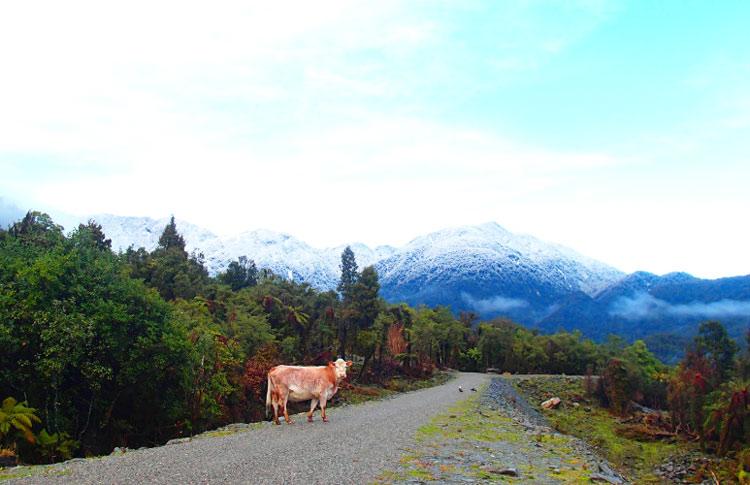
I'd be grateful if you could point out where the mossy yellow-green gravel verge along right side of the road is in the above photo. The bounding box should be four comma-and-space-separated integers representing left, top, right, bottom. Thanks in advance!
388, 377, 628, 485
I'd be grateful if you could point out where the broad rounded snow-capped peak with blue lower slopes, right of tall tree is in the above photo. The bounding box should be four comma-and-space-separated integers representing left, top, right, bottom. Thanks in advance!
377, 223, 624, 324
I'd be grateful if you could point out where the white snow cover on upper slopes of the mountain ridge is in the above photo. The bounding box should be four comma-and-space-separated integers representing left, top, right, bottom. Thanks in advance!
87, 214, 622, 294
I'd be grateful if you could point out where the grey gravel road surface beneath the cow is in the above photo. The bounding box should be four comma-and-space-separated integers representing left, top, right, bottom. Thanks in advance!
9, 373, 490, 484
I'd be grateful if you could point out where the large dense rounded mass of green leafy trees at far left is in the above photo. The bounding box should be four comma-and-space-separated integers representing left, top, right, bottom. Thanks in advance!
0, 224, 194, 451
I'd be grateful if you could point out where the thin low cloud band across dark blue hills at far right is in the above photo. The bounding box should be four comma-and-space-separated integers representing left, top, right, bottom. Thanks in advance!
609, 292, 750, 320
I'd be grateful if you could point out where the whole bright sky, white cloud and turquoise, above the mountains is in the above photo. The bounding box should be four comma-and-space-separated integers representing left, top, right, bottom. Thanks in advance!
0, 0, 750, 277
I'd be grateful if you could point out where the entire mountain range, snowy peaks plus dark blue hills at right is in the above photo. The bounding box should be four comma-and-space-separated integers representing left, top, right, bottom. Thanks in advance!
2, 206, 750, 354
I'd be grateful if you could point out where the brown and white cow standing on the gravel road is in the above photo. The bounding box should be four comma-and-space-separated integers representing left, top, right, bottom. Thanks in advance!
266, 359, 352, 424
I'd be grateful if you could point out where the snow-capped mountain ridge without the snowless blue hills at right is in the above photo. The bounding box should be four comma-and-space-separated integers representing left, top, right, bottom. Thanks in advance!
82, 215, 624, 324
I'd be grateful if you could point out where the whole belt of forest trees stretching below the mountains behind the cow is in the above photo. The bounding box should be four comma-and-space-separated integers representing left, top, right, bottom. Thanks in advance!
0, 212, 750, 463
